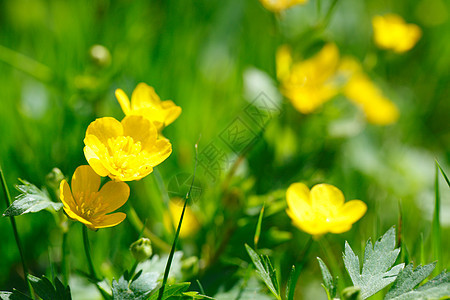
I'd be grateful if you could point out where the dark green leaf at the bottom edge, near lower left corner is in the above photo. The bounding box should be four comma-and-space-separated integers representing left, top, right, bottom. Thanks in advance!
28, 274, 72, 300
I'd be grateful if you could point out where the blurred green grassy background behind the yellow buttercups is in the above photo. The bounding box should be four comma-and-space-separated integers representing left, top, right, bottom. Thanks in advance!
0, 0, 450, 299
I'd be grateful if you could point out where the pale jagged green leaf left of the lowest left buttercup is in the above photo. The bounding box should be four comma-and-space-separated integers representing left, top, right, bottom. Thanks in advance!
3, 179, 63, 217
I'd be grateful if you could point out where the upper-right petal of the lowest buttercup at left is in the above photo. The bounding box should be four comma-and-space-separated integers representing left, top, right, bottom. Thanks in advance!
98, 181, 130, 214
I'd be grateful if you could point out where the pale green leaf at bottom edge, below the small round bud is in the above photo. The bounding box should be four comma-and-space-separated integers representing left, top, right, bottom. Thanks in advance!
112, 272, 159, 300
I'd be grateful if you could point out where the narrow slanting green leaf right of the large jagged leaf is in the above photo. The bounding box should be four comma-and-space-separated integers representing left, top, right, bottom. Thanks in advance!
385, 263, 436, 299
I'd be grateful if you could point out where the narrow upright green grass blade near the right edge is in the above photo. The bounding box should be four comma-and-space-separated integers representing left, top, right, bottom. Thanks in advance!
432, 162, 442, 273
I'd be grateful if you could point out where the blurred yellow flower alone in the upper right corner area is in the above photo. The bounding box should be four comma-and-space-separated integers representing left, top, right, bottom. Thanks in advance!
372, 14, 422, 53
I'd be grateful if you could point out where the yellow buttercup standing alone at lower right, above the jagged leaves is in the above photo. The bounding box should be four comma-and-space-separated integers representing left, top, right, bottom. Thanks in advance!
286, 183, 367, 236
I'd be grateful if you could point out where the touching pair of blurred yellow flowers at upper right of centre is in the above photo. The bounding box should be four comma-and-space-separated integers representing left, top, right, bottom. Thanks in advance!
276, 43, 399, 125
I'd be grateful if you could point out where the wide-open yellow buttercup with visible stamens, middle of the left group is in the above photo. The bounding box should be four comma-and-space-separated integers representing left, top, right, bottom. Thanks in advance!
84, 115, 172, 181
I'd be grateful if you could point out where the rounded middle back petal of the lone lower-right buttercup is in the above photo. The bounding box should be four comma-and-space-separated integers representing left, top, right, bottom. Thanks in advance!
311, 183, 345, 210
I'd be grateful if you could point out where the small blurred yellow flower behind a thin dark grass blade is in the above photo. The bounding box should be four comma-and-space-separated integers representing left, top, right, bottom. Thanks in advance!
163, 197, 200, 238
